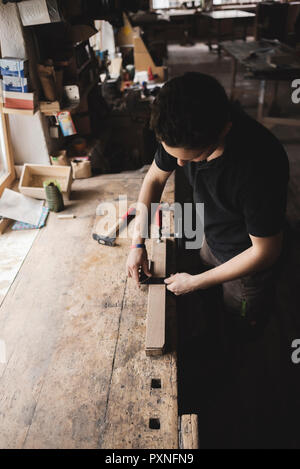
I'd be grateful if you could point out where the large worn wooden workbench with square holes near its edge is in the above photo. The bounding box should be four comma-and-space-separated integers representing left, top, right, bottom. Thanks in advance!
0, 171, 178, 449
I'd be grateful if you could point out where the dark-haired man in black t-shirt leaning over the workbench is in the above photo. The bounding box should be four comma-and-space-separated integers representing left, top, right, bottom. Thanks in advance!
127, 73, 289, 326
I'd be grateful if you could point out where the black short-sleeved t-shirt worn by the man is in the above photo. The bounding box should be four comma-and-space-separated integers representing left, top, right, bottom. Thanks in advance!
155, 105, 289, 262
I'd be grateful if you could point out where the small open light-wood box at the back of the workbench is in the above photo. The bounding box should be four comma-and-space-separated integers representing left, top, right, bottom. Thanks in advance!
19, 164, 72, 199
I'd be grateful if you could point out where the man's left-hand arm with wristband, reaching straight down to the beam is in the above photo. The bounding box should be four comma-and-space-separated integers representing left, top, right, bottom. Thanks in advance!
126, 161, 172, 284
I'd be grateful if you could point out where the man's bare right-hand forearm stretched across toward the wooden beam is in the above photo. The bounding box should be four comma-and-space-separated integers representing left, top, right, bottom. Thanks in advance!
166, 233, 282, 295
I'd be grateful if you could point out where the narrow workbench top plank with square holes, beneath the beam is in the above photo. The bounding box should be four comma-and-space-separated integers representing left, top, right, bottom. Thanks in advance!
101, 238, 179, 449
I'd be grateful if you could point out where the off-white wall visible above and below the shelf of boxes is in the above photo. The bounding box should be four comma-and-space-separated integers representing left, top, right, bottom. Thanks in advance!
0, 2, 50, 165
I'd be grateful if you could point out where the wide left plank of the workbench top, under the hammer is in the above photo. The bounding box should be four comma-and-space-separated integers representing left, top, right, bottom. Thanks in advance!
0, 177, 141, 448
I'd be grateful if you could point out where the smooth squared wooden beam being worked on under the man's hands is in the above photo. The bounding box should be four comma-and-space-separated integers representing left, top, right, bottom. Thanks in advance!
146, 239, 166, 356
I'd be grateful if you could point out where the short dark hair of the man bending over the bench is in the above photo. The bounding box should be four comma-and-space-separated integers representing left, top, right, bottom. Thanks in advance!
150, 72, 230, 149
